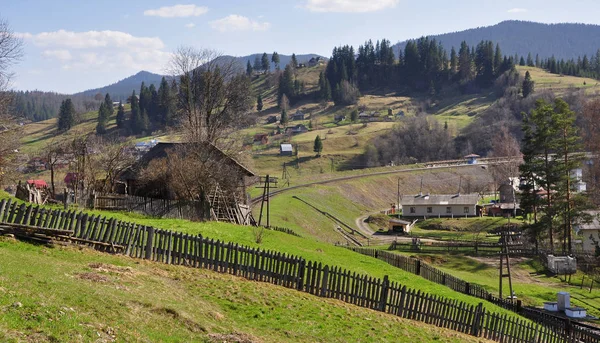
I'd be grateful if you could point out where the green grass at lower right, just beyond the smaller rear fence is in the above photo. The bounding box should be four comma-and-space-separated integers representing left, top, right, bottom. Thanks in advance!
392, 253, 600, 316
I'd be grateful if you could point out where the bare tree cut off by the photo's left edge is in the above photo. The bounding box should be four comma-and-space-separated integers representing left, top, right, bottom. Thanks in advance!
0, 19, 23, 184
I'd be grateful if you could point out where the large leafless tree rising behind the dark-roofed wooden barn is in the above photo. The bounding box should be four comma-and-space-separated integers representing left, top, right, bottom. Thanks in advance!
168, 47, 252, 143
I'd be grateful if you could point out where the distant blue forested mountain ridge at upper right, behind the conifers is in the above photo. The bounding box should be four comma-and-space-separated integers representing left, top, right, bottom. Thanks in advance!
394, 20, 600, 59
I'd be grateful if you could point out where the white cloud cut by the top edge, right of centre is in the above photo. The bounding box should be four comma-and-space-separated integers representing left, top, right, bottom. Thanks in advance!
304, 0, 399, 13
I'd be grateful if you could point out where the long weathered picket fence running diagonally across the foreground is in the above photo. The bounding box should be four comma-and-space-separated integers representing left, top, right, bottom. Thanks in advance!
0, 200, 600, 343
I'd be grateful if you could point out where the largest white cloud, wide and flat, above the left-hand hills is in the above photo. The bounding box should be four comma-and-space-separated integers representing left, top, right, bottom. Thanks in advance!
18, 30, 171, 72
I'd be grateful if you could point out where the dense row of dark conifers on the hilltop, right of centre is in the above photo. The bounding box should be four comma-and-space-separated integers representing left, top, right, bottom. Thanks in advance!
318, 37, 518, 105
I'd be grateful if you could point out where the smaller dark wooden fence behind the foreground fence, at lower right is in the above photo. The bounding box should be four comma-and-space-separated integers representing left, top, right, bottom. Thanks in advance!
349, 247, 600, 342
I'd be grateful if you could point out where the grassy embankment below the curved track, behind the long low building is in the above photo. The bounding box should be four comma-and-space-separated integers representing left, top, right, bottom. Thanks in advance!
262, 166, 490, 243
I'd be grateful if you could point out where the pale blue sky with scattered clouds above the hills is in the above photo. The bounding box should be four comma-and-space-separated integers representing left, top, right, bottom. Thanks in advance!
0, 0, 600, 94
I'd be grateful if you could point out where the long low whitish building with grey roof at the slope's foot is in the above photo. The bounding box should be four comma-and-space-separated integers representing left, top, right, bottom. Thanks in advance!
400, 194, 480, 218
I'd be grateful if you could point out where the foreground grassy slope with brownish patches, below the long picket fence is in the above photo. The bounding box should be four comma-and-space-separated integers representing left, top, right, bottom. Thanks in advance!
0, 240, 488, 342
